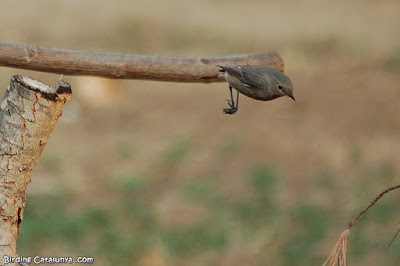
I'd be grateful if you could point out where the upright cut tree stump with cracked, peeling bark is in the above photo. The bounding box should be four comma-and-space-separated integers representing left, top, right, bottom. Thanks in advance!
0, 76, 72, 265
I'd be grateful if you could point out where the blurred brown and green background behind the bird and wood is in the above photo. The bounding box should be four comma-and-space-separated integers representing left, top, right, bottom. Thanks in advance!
0, 0, 400, 265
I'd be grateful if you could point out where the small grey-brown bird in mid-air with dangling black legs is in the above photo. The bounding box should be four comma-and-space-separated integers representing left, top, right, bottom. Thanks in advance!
219, 65, 296, 114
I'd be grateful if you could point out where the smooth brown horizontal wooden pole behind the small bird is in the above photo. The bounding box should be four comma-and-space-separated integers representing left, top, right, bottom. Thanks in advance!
0, 42, 284, 83
